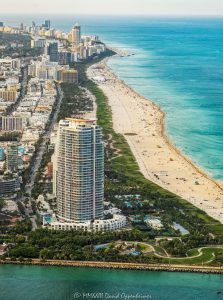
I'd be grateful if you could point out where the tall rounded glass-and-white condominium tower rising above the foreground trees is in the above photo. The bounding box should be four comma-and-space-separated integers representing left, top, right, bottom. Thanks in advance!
54, 119, 104, 222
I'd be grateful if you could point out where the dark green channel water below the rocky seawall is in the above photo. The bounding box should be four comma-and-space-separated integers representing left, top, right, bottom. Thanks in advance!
0, 265, 223, 300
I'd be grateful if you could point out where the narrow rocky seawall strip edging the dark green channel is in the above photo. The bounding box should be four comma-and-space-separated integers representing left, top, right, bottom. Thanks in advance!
0, 258, 223, 275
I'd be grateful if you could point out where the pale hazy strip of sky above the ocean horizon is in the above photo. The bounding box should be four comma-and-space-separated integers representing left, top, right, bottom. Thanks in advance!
0, 0, 223, 15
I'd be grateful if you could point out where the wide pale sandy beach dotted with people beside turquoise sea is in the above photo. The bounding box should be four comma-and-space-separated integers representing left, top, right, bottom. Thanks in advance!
87, 59, 223, 223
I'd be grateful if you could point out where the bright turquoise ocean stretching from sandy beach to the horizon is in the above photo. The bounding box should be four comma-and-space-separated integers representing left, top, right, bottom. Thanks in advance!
0, 15, 223, 181
